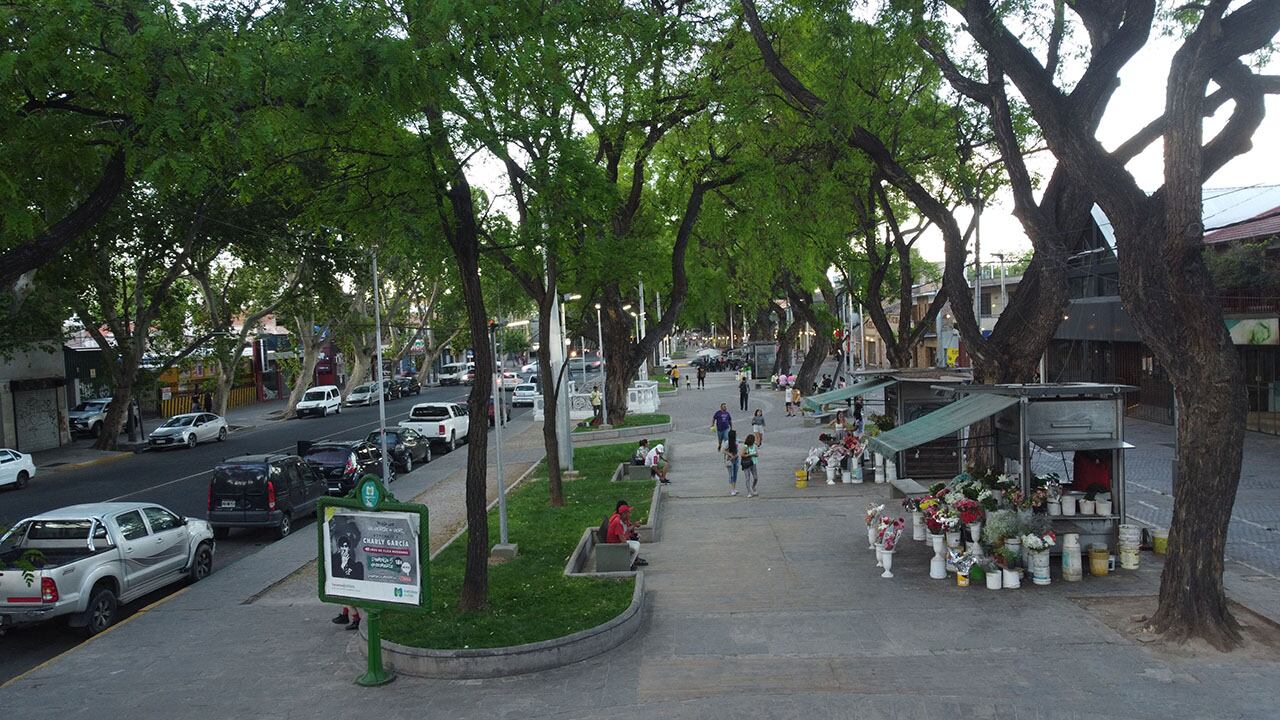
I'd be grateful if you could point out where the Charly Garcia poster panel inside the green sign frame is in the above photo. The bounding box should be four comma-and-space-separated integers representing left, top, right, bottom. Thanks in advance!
323, 507, 422, 606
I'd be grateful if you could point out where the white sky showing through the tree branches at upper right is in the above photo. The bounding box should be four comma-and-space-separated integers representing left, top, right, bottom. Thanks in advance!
919, 35, 1280, 263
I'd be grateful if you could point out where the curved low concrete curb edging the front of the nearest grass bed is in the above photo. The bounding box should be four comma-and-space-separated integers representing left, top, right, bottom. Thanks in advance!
358, 573, 645, 680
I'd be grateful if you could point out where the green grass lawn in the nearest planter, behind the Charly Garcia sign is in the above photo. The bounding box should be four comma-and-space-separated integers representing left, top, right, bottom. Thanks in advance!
383, 442, 654, 650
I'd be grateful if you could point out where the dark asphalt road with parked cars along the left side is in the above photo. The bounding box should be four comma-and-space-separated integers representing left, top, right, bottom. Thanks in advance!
0, 387, 527, 683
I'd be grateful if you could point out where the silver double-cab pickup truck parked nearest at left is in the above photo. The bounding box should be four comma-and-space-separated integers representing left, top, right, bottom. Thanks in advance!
0, 502, 215, 635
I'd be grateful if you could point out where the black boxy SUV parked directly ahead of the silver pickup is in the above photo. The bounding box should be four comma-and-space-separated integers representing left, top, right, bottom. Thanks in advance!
207, 454, 326, 538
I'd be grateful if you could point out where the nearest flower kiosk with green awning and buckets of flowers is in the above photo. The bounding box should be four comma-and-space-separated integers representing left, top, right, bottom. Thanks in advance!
868, 383, 1138, 587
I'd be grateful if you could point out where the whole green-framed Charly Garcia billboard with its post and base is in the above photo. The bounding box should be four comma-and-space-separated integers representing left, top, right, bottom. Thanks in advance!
316, 475, 431, 687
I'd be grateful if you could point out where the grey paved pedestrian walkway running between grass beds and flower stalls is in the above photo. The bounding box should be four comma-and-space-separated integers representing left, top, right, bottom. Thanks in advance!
0, 366, 1280, 720
